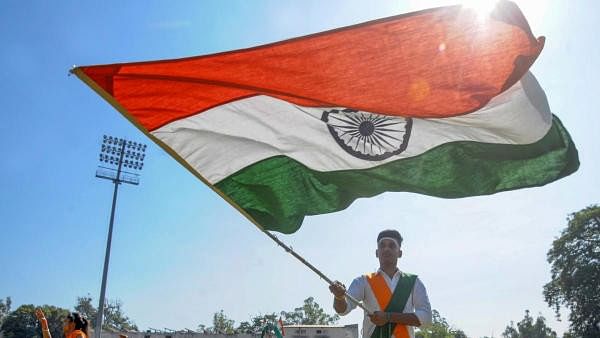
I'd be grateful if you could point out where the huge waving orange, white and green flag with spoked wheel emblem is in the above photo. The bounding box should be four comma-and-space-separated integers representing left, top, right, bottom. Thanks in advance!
73, 1, 579, 233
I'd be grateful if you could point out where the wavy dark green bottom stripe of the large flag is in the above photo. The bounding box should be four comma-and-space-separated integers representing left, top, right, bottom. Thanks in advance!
216, 117, 579, 233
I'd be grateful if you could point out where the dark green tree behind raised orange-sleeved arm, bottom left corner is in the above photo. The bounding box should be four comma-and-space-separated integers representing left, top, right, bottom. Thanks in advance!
2, 304, 69, 338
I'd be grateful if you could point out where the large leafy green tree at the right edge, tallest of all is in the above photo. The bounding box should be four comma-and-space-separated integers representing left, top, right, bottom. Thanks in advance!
544, 205, 600, 338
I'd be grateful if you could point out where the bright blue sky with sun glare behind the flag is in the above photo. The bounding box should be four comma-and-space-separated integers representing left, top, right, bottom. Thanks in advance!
0, 0, 600, 337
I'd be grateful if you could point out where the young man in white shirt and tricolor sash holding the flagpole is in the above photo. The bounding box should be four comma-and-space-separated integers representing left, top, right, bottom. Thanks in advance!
329, 230, 431, 338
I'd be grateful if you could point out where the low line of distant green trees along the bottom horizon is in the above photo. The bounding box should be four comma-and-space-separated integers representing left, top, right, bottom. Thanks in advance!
0, 290, 556, 338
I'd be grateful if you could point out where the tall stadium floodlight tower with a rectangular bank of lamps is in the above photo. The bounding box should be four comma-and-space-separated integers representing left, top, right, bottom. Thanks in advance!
94, 135, 146, 338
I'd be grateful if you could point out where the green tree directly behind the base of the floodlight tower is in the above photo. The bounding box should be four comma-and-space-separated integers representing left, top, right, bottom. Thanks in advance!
75, 295, 138, 331
